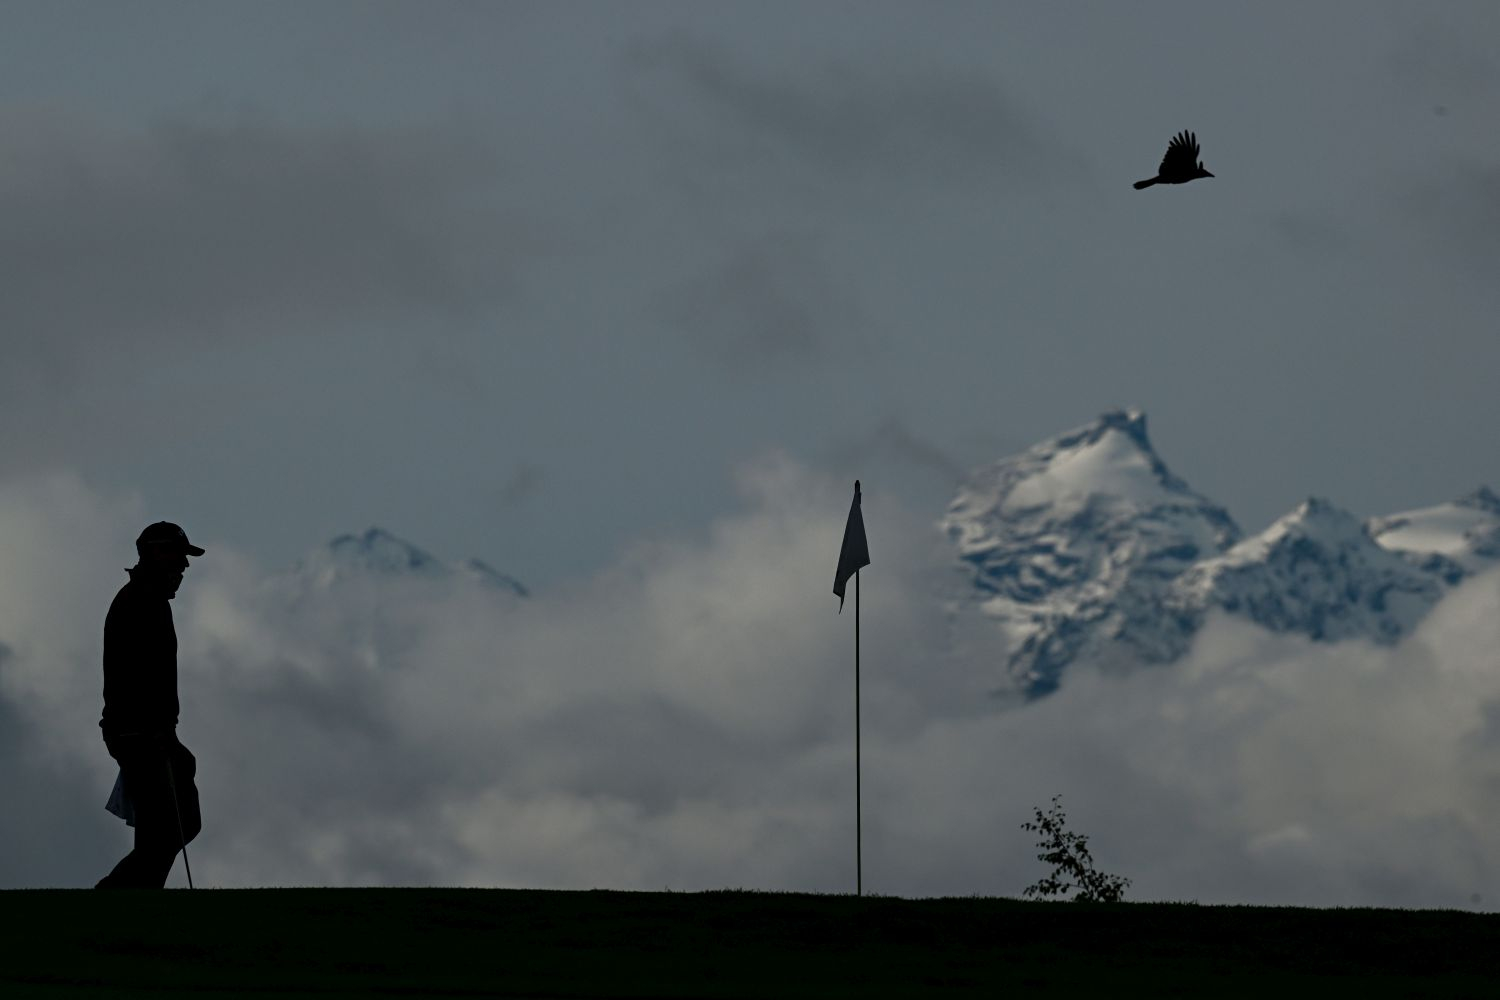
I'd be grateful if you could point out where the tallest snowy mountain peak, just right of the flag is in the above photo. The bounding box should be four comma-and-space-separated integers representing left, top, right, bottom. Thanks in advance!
941, 409, 1241, 694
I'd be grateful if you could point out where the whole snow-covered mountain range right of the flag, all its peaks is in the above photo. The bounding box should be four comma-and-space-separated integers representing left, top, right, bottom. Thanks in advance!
939, 409, 1500, 696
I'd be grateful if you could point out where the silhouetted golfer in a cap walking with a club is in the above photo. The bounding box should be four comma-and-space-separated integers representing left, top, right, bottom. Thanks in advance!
96, 520, 203, 889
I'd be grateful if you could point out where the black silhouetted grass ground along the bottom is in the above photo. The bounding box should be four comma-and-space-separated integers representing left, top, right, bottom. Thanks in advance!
0, 889, 1500, 1000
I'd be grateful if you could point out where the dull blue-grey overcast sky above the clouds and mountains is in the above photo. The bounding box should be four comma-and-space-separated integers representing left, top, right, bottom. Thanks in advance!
0, 3, 1500, 586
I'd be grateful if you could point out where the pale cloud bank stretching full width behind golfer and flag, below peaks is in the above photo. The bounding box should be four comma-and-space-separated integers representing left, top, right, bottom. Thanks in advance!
0, 459, 1500, 907
